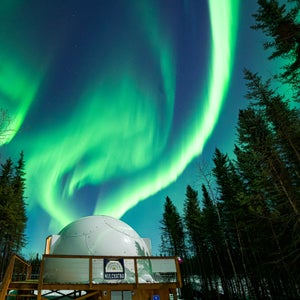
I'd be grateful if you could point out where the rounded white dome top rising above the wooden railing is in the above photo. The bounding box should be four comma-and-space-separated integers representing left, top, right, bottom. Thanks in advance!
50, 215, 150, 256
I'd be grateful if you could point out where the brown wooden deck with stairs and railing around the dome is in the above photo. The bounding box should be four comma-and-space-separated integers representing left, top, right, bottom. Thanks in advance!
0, 255, 181, 300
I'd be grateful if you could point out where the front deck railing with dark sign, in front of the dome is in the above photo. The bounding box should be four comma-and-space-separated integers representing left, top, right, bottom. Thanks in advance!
40, 255, 181, 286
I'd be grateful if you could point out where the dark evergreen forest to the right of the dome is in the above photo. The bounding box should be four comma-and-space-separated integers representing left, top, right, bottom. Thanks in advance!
161, 0, 300, 299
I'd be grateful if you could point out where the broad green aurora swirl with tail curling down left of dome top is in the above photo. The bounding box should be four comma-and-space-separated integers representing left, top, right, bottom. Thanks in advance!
27, 70, 166, 228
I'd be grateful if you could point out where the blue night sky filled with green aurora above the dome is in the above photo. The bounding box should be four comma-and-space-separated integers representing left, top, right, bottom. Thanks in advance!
0, 0, 272, 254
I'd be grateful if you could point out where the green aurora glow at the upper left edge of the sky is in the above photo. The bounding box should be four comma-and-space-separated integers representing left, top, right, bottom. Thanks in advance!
0, 0, 52, 146
